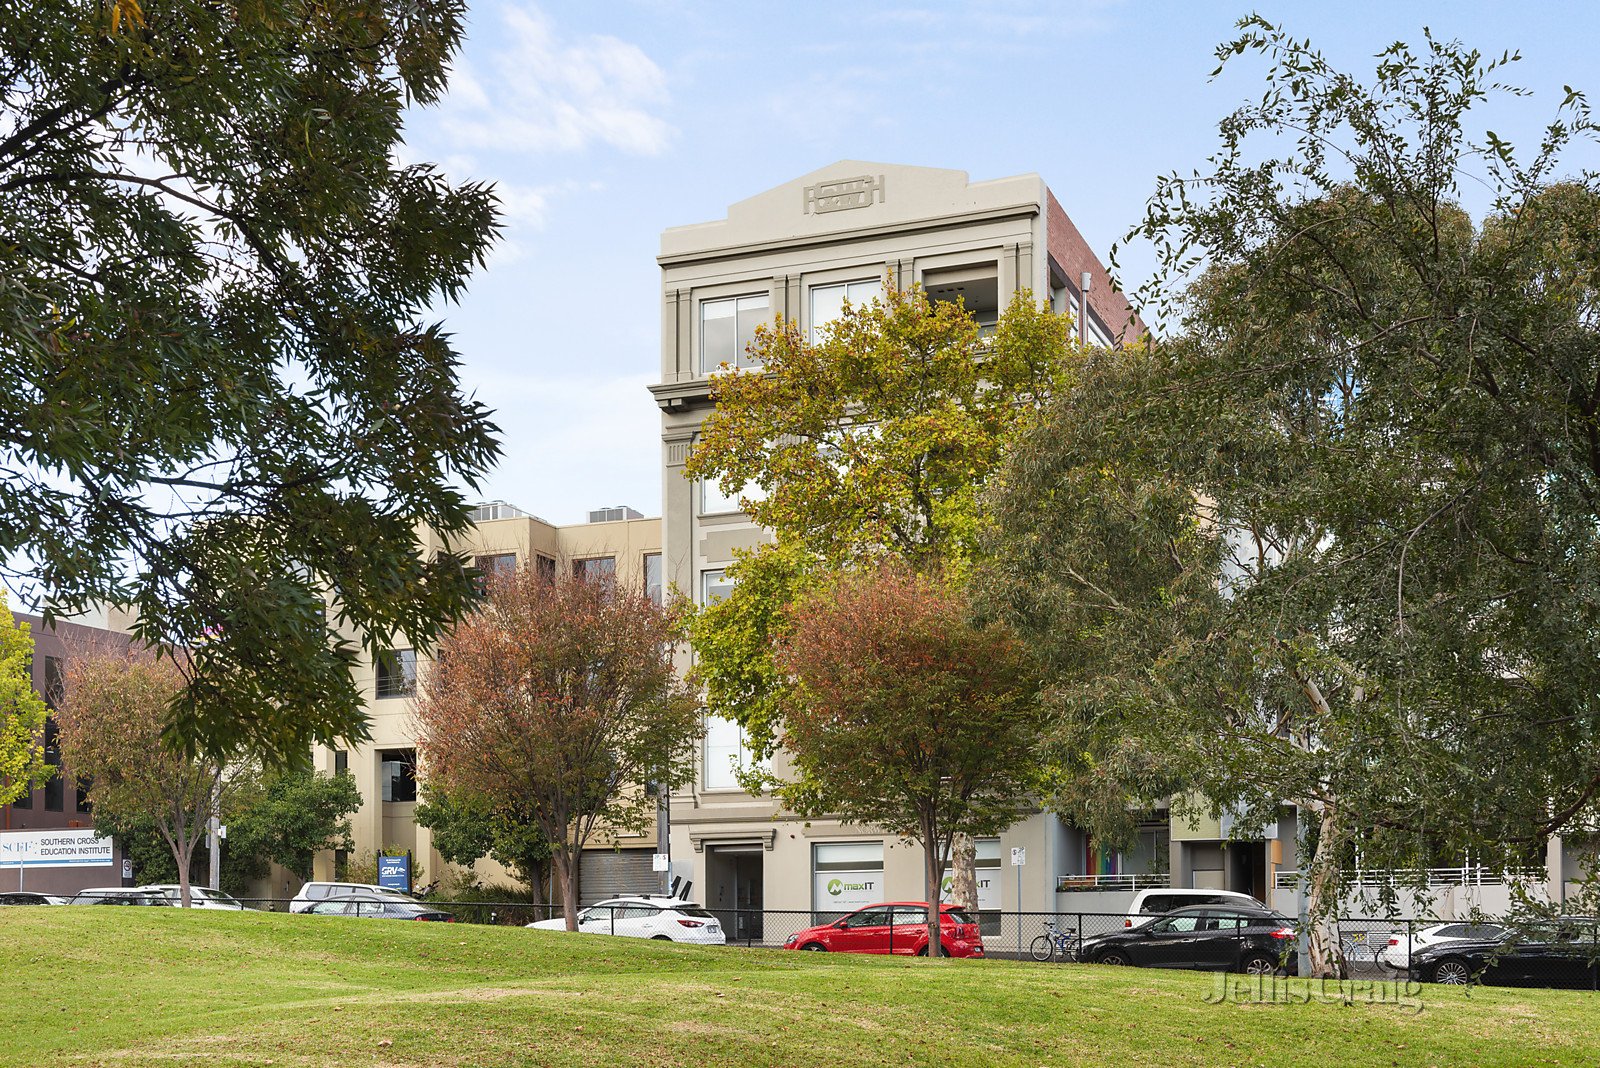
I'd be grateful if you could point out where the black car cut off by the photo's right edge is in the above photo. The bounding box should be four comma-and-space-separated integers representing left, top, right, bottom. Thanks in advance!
1410, 916, 1600, 990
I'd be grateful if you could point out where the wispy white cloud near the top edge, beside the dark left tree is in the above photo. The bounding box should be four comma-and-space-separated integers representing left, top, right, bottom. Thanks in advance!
437, 5, 674, 155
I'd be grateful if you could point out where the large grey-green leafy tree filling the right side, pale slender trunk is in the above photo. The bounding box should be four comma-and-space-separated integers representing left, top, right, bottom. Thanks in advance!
992, 18, 1600, 974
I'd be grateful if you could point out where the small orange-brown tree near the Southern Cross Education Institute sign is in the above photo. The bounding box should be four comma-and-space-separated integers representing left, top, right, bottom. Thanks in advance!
56, 654, 229, 908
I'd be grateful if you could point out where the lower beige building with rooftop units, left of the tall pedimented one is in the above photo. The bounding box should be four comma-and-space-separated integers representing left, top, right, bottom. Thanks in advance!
305, 502, 662, 900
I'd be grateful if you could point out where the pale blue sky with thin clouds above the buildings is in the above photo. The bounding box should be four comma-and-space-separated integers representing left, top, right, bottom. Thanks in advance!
400, 0, 1600, 523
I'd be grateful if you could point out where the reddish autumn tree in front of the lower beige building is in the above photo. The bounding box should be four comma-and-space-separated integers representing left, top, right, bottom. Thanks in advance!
418, 568, 701, 931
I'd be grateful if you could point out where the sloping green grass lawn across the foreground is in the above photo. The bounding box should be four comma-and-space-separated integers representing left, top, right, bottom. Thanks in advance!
0, 908, 1600, 1068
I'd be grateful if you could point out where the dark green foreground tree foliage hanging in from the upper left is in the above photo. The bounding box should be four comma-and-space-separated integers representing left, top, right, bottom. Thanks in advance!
0, 0, 498, 761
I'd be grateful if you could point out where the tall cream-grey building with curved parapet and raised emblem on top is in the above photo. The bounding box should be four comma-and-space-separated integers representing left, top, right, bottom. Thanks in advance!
650, 160, 1170, 937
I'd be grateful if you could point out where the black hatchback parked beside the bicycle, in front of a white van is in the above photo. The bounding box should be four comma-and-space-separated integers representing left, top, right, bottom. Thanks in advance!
1078, 905, 1296, 975
